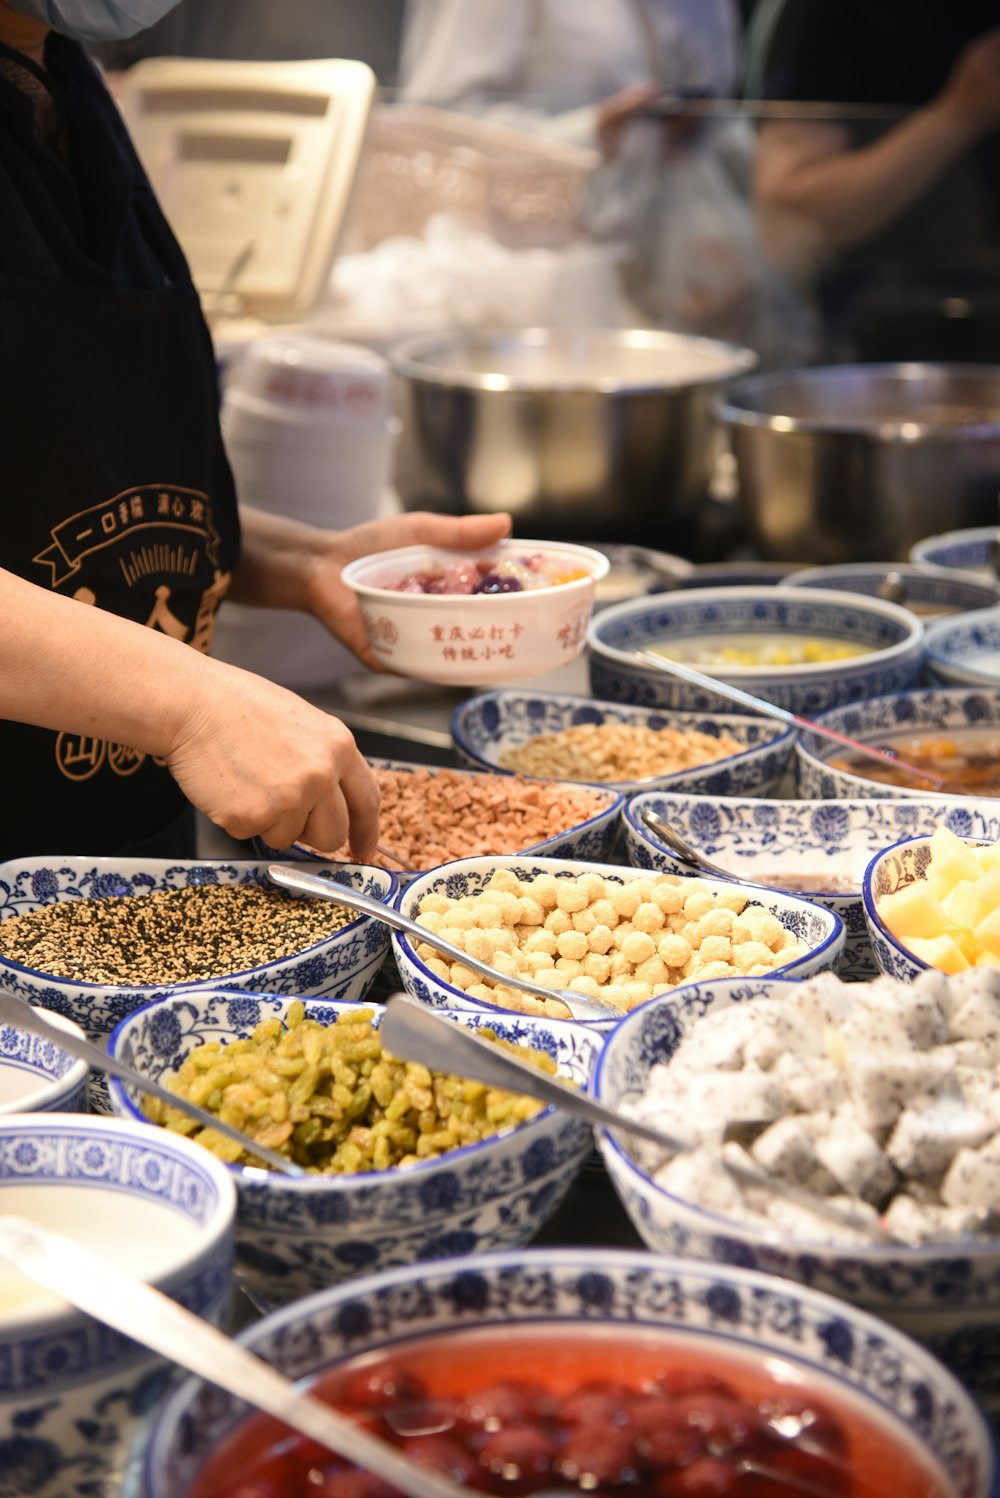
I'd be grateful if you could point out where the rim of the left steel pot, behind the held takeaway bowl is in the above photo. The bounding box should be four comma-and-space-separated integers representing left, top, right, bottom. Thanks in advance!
388, 327, 757, 395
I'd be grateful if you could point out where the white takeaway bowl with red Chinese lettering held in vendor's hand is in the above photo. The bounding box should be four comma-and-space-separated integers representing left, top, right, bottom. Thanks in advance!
341, 541, 609, 686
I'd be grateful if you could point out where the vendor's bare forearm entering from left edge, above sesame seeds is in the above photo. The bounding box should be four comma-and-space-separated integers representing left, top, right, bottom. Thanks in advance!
0, 571, 213, 755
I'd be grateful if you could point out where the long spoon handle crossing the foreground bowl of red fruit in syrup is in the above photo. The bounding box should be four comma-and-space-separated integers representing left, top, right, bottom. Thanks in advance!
0, 1216, 469, 1498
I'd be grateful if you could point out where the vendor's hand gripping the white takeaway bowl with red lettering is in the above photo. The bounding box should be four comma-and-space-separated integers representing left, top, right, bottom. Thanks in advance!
308, 509, 510, 668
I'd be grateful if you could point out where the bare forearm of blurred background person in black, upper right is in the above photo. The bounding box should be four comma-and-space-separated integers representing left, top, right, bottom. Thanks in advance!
757, 103, 970, 250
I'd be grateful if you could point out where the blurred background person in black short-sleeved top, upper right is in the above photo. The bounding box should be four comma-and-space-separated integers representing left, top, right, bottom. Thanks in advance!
749, 0, 1000, 360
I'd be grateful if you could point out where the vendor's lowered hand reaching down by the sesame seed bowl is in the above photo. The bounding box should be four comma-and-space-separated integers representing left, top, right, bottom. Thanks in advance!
163, 658, 379, 863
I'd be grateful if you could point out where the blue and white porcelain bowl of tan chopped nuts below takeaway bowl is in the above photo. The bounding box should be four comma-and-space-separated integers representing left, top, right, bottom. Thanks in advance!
452, 691, 793, 802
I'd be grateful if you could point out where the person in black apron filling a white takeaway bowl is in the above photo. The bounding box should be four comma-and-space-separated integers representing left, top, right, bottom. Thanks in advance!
0, 0, 504, 860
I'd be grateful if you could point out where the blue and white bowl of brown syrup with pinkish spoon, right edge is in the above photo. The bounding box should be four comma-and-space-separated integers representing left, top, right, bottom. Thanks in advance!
795, 686, 1000, 802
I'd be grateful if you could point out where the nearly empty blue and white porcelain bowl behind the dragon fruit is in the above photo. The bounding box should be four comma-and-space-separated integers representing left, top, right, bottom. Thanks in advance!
624, 791, 1000, 981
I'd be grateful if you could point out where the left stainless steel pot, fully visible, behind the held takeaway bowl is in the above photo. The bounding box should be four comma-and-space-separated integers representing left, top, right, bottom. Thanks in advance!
391, 328, 756, 545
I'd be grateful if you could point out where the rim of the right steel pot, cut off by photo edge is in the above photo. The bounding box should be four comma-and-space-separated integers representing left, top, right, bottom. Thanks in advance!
713, 360, 1000, 446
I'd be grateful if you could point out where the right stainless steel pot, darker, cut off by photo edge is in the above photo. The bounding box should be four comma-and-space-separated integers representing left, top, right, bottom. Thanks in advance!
716, 364, 1000, 563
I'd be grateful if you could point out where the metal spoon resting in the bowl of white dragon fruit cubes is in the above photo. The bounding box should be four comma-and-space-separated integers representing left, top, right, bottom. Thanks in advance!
379, 993, 900, 1243
